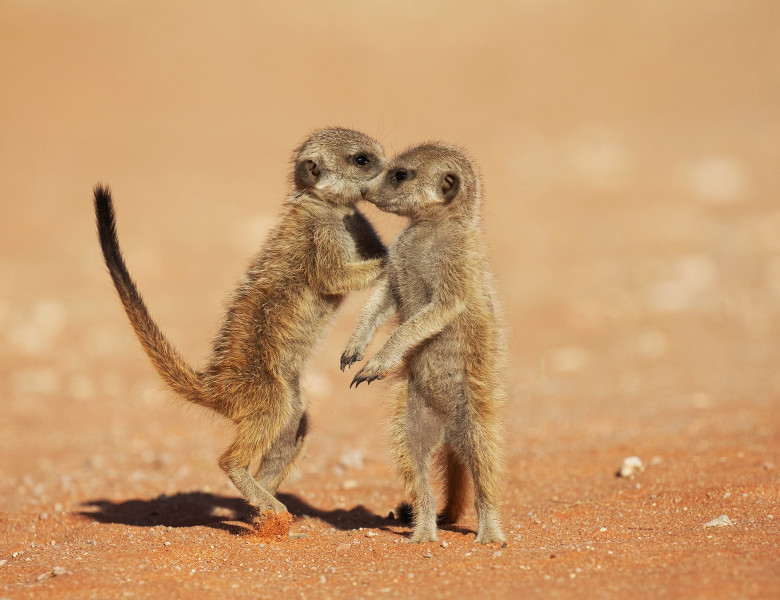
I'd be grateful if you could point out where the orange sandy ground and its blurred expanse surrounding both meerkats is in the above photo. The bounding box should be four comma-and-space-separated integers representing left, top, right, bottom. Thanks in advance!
0, 0, 780, 599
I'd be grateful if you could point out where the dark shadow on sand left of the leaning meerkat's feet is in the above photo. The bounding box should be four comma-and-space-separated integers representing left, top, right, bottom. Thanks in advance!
79, 492, 252, 535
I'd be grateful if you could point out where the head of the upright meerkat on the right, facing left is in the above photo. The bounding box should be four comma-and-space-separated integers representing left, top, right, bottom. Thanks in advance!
366, 142, 481, 219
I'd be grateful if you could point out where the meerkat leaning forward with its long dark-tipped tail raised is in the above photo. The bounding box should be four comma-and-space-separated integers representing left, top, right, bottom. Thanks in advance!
94, 128, 386, 516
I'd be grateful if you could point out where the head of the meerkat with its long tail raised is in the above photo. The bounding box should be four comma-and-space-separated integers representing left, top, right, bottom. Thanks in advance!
293, 127, 387, 204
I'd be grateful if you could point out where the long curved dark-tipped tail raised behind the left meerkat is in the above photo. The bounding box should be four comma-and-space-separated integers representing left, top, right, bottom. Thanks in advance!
94, 184, 210, 406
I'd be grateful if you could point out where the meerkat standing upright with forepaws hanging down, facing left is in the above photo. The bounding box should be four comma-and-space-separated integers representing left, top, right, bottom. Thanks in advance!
341, 143, 505, 544
